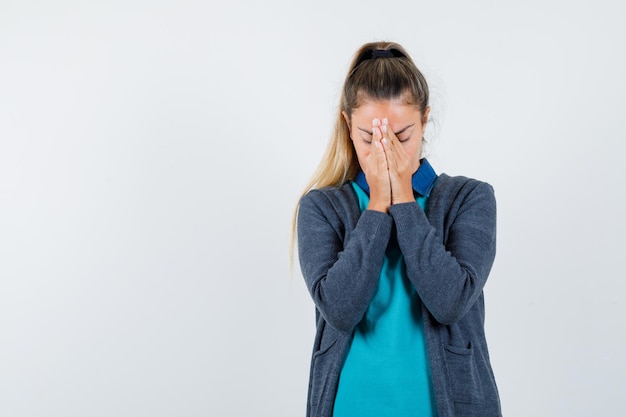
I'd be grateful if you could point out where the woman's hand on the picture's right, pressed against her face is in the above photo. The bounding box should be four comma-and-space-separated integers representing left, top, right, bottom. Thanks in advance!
381, 118, 415, 204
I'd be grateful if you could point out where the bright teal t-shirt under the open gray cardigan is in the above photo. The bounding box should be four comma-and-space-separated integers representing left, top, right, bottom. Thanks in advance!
333, 182, 437, 417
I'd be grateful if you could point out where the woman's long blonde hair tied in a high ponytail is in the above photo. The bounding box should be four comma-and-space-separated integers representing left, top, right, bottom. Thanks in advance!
289, 42, 429, 266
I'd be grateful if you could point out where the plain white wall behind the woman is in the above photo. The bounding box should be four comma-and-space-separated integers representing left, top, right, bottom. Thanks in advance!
0, 0, 626, 417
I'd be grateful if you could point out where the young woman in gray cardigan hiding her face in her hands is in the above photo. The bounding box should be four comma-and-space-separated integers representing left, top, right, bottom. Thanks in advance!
290, 42, 501, 417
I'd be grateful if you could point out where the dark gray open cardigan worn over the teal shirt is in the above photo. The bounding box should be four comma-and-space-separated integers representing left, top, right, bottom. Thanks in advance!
298, 174, 501, 417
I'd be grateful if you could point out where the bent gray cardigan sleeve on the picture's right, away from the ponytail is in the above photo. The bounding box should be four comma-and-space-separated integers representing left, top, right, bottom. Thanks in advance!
390, 181, 496, 325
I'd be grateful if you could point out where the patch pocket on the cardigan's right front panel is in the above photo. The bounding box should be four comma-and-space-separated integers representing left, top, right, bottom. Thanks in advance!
445, 343, 484, 404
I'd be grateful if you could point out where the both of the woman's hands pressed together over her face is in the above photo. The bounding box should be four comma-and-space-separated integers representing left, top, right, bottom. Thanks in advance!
362, 118, 415, 213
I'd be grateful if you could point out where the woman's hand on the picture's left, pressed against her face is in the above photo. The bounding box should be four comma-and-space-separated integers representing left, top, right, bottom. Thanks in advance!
363, 119, 391, 213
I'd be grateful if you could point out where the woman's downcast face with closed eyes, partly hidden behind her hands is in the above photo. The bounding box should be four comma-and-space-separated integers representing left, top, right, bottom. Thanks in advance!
343, 98, 430, 173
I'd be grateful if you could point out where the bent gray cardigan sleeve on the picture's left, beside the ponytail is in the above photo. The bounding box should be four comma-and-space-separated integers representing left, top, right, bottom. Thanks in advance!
297, 190, 392, 332
